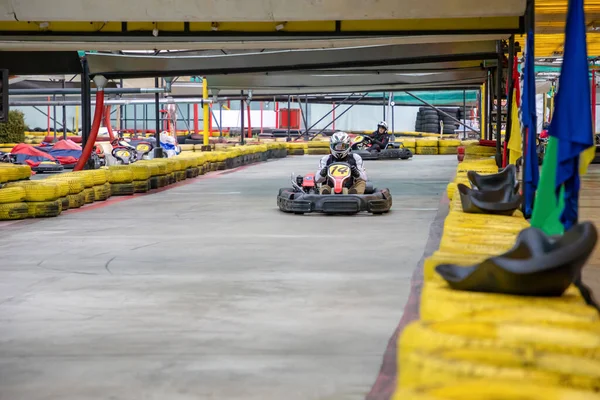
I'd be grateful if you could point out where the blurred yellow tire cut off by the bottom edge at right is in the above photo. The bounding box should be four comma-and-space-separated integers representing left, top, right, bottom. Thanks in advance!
392, 379, 600, 400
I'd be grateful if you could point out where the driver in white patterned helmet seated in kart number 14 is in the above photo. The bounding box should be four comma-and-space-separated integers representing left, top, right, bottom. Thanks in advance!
315, 132, 367, 194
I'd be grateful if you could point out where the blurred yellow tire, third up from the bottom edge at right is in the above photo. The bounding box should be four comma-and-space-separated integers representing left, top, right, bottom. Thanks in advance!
399, 318, 600, 360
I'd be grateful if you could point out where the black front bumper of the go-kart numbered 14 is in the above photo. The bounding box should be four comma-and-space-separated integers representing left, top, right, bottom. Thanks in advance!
277, 189, 392, 214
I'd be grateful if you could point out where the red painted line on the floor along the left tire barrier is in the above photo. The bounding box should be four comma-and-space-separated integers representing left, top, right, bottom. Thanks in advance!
0, 163, 259, 228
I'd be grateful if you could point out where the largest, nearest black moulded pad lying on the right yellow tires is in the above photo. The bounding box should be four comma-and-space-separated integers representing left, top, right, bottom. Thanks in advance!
435, 222, 598, 297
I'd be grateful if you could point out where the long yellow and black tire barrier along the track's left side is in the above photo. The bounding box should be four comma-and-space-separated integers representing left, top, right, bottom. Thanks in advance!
0, 143, 287, 221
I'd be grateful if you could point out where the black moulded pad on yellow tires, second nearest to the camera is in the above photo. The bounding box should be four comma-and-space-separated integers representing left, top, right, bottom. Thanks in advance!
458, 183, 523, 215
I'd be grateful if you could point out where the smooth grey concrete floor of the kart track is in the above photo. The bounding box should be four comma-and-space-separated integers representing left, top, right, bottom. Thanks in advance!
0, 156, 456, 400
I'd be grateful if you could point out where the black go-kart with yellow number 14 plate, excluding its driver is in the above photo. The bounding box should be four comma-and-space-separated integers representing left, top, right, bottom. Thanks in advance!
277, 162, 392, 214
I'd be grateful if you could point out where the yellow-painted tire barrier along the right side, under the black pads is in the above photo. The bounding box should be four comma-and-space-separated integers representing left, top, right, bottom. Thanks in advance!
393, 159, 600, 400
